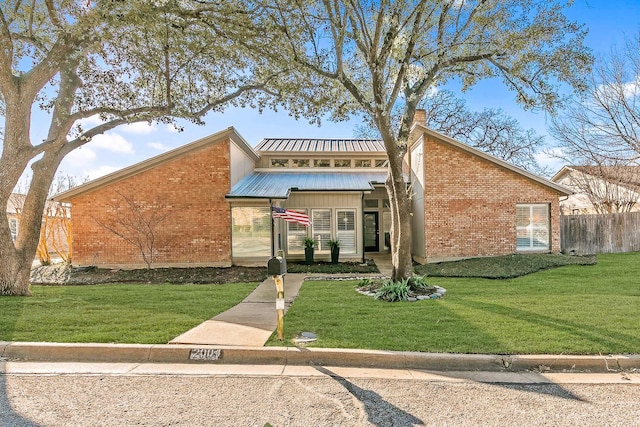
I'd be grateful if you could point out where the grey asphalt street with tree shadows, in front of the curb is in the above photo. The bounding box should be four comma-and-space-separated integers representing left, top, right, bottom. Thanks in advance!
0, 362, 640, 427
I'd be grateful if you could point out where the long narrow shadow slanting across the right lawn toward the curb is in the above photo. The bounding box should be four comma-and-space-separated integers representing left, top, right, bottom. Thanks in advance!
456, 299, 638, 353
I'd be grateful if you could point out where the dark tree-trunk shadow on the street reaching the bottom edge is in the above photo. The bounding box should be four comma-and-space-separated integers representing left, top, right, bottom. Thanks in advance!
314, 366, 424, 426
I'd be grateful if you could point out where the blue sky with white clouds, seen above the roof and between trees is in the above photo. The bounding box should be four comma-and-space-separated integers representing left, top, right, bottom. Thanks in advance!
53, 0, 640, 179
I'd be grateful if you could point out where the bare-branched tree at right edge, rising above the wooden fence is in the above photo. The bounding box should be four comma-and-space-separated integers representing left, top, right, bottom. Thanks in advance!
549, 36, 640, 217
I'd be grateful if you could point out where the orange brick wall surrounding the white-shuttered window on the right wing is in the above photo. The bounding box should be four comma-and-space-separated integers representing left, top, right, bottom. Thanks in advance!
424, 135, 560, 259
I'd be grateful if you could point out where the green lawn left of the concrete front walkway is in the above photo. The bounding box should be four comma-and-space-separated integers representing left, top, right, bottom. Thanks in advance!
0, 283, 256, 344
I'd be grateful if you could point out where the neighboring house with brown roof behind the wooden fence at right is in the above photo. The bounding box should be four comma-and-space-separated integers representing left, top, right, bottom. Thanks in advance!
551, 166, 640, 215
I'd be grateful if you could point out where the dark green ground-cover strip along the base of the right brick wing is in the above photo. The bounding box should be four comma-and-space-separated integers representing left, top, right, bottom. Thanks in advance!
415, 254, 596, 279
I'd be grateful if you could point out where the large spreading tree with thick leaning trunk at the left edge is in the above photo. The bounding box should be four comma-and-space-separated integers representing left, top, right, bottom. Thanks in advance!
0, 0, 322, 295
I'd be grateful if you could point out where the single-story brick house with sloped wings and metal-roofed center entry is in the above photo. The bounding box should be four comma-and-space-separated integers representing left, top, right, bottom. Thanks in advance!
55, 115, 571, 267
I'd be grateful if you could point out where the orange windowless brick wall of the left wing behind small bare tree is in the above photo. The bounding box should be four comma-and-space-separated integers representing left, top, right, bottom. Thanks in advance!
71, 140, 231, 268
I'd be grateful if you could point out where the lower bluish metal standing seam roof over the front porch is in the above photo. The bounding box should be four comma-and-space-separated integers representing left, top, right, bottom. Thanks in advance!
227, 171, 387, 199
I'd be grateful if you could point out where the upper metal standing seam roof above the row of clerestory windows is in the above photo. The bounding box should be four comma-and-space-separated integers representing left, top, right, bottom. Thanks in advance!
255, 138, 386, 153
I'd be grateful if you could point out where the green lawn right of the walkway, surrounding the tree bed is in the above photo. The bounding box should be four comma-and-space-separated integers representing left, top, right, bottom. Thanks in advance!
268, 253, 640, 354
